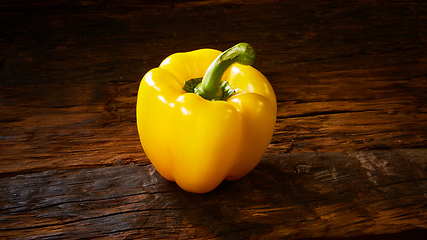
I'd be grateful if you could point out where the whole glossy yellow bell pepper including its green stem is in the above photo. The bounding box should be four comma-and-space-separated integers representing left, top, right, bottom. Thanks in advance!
136, 43, 277, 193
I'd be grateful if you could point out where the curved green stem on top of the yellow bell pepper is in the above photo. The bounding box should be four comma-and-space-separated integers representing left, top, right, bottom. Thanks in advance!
194, 43, 255, 101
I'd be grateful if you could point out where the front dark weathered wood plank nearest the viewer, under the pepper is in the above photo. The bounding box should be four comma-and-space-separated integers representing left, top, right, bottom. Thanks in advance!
0, 149, 427, 239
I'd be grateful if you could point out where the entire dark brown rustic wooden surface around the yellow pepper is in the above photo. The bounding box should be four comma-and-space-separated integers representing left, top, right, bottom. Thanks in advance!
0, 0, 427, 239
